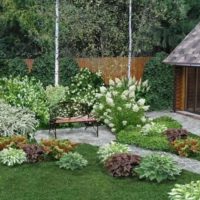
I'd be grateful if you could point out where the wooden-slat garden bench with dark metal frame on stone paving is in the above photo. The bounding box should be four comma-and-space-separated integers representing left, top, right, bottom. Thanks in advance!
49, 102, 99, 138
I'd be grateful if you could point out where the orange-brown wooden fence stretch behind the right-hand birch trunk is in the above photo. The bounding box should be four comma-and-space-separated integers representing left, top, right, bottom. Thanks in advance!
76, 57, 150, 84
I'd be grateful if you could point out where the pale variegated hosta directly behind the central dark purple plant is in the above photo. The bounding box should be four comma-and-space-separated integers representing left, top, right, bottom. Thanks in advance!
97, 142, 129, 163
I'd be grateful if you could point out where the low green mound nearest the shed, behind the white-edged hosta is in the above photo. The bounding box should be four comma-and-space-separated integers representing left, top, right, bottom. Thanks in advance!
153, 116, 182, 128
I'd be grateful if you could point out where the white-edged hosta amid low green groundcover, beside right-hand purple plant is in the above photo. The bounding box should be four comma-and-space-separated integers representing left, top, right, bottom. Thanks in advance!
141, 122, 168, 135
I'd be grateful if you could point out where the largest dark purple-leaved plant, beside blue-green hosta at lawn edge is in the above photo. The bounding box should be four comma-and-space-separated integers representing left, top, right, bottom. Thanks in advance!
105, 153, 141, 177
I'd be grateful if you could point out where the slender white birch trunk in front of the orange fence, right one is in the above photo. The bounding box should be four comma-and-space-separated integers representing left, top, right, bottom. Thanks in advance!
128, 0, 132, 79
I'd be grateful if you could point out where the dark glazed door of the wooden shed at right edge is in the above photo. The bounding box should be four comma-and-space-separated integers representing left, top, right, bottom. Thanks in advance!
186, 67, 200, 113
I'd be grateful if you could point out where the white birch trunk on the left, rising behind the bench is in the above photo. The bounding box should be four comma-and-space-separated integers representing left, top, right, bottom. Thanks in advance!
55, 0, 59, 86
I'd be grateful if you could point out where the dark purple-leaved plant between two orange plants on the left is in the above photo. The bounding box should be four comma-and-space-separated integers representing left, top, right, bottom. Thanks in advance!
22, 144, 44, 163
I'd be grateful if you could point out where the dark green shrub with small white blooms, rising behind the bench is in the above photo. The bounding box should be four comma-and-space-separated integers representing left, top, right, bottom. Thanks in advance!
66, 68, 103, 106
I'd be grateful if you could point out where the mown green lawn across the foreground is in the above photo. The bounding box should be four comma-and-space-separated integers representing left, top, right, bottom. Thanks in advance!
0, 145, 200, 200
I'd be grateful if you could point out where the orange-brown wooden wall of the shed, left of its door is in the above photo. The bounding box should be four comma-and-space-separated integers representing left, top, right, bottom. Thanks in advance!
175, 67, 186, 110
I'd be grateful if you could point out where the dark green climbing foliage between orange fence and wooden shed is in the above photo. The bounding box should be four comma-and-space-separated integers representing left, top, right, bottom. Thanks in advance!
143, 52, 174, 110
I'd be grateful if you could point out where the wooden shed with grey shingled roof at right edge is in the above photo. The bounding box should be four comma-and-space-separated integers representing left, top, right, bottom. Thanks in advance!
164, 23, 200, 114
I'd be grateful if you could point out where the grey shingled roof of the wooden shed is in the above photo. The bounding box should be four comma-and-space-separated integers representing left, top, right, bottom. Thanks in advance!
163, 23, 200, 66
